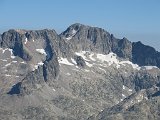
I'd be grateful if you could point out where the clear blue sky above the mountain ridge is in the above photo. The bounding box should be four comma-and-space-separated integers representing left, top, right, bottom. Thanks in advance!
0, 0, 160, 51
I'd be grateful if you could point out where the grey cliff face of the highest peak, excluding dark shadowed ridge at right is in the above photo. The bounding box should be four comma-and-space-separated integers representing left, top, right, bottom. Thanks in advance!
60, 23, 132, 59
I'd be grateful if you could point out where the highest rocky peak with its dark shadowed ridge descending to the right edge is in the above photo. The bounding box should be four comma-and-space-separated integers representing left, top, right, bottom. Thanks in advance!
60, 23, 160, 67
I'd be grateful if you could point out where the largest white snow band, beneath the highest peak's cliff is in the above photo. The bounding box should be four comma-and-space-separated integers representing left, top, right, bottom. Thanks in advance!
74, 51, 157, 70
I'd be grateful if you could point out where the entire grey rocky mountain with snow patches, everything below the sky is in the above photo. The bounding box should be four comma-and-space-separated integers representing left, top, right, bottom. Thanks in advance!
0, 23, 160, 120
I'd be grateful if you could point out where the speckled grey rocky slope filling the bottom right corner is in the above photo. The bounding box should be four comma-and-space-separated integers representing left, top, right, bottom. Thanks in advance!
89, 97, 160, 120
